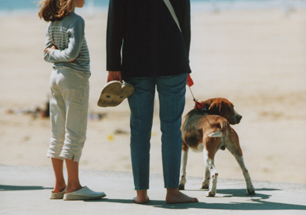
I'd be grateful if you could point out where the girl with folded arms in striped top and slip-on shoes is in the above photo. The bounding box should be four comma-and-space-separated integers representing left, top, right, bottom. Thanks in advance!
38, 0, 105, 200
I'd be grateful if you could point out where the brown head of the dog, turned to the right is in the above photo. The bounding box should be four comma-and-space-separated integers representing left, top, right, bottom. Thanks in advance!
201, 98, 242, 125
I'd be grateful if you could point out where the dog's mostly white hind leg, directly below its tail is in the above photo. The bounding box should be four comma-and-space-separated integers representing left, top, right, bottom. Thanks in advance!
203, 148, 218, 197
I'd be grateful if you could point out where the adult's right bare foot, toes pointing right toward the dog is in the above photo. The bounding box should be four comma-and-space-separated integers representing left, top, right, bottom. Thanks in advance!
166, 188, 199, 204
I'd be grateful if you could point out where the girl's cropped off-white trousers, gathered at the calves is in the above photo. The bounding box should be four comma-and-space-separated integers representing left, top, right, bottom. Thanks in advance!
47, 67, 90, 162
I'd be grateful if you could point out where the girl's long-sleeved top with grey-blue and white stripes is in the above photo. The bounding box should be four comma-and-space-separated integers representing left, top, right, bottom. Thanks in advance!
44, 12, 90, 72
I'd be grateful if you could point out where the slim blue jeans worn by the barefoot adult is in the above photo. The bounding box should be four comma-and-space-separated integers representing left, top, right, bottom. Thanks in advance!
128, 74, 187, 190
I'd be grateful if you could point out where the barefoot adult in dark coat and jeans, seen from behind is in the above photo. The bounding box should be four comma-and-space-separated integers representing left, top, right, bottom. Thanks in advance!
107, 0, 198, 203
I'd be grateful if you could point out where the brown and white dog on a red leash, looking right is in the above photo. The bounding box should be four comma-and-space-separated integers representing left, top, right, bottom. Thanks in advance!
180, 98, 255, 197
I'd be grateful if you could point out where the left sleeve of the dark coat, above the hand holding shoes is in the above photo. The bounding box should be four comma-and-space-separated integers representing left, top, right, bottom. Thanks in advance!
106, 0, 126, 71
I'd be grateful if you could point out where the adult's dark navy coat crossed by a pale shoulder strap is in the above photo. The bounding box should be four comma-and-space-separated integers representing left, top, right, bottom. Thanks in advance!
107, 0, 191, 80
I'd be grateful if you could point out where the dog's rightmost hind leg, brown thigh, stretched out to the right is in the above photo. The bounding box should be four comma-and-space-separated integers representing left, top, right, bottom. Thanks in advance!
226, 129, 255, 195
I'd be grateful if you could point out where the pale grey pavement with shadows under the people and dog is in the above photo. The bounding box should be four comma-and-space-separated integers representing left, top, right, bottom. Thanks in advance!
0, 165, 306, 215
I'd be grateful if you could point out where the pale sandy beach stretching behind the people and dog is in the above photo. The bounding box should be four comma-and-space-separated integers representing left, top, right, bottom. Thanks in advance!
0, 9, 306, 184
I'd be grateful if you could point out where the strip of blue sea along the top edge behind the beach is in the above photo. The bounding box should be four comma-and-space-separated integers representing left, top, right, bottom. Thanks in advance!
0, 0, 306, 15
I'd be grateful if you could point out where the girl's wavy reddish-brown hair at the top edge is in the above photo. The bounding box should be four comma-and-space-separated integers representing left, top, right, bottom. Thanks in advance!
38, 0, 74, 22
